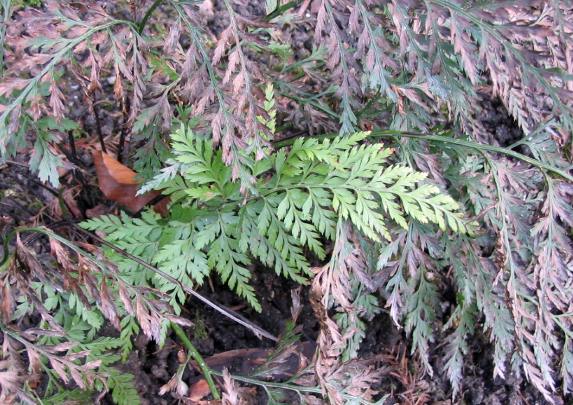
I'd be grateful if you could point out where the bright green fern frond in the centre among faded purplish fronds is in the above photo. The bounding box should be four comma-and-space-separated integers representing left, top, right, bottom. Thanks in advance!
83, 125, 468, 311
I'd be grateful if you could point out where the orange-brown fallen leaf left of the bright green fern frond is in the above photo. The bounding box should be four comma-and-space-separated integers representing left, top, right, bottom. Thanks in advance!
93, 150, 169, 215
